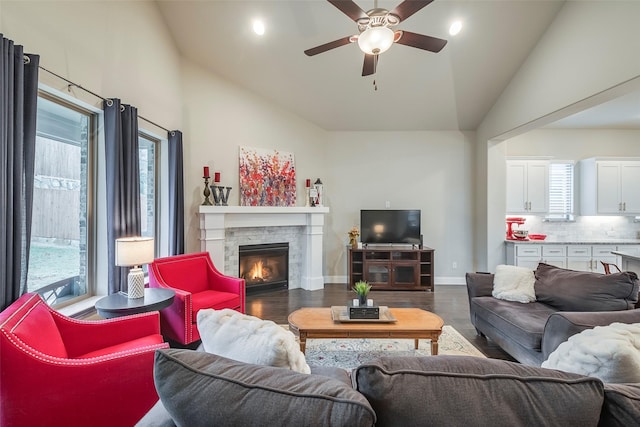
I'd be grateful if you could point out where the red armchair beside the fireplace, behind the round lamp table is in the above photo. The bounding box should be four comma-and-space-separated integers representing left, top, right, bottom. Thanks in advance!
149, 252, 245, 345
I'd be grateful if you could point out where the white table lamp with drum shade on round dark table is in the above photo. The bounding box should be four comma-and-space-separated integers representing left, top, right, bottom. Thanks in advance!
116, 236, 154, 298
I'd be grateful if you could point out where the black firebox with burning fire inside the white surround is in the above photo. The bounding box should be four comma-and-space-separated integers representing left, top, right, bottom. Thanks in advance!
238, 242, 289, 294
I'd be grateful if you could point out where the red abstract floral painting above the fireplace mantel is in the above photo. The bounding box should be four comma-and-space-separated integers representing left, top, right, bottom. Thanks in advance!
239, 147, 296, 206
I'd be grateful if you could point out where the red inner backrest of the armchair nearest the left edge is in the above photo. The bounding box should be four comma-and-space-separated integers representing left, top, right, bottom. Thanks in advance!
11, 302, 69, 359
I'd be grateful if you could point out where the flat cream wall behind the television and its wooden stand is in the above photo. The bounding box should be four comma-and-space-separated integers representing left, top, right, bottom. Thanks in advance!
322, 132, 475, 283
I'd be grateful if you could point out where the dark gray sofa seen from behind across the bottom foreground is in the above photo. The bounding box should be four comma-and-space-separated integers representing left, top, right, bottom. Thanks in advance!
138, 349, 640, 427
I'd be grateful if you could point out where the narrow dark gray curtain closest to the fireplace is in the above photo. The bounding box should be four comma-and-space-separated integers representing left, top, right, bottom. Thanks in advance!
169, 130, 184, 255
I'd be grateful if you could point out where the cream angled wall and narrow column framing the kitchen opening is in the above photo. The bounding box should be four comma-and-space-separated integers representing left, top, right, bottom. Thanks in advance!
476, 1, 640, 270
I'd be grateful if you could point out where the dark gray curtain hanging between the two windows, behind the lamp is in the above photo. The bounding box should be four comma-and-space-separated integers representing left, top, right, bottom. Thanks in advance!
103, 99, 142, 294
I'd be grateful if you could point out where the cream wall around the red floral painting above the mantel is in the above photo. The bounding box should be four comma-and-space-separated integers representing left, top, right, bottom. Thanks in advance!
183, 61, 327, 252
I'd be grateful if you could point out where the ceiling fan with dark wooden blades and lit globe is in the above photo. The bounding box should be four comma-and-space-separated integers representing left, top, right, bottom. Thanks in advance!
304, 0, 447, 76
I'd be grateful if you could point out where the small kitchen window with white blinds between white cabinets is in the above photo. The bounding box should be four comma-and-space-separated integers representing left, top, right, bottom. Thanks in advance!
547, 162, 574, 221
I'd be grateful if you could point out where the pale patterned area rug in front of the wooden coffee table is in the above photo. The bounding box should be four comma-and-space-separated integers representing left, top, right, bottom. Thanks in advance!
283, 325, 485, 370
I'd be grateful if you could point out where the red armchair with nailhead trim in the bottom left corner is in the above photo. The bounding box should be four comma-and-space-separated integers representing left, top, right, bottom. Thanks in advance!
0, 293, 169, 427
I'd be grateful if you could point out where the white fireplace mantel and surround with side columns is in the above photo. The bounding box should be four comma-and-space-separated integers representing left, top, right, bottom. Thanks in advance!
198, 206, 329, 290
